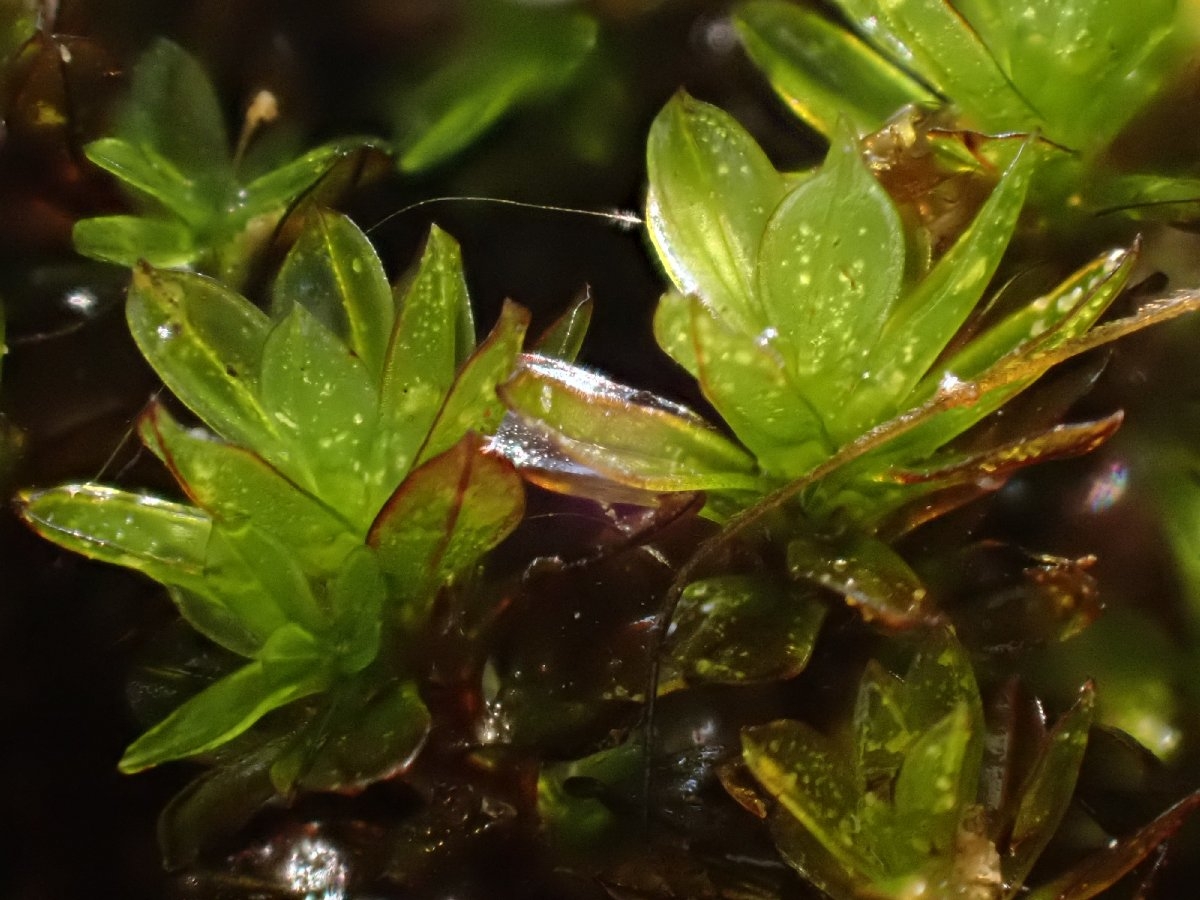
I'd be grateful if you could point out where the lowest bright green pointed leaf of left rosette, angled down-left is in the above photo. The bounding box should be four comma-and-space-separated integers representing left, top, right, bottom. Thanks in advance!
120, 626, 330, 773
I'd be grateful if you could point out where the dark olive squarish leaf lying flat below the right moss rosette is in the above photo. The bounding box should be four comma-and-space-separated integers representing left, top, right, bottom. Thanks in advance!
670, 575, 826, 684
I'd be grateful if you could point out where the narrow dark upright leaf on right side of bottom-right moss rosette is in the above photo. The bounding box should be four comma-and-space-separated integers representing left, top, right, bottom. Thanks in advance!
1003, 684, 1096, 884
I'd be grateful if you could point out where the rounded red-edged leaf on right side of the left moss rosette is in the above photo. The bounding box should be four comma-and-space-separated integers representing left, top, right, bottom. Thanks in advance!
368, 434, 524, 625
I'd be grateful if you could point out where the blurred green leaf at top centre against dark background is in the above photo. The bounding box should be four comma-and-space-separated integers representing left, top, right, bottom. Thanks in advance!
396, 10, 598, 173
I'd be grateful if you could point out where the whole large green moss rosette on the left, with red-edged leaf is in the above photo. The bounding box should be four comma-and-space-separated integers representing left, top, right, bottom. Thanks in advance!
22, 212, 527, 791
